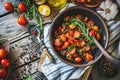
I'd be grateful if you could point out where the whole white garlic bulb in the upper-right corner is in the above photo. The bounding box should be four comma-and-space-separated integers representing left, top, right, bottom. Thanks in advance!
97, 0, 118, 20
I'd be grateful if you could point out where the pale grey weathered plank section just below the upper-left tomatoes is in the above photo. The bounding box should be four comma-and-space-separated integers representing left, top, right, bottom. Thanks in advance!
0, 14, 26, 38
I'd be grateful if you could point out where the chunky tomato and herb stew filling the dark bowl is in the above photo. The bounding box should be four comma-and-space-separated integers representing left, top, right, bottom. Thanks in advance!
53, 14, 101, 64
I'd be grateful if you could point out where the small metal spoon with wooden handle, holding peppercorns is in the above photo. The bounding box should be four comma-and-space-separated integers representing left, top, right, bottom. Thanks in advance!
28, 25, 55, 63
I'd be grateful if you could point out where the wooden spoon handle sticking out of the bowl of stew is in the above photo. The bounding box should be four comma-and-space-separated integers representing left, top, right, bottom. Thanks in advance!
93, 37, 120, 68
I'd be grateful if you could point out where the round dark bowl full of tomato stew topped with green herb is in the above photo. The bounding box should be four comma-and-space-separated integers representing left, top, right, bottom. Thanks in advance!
50, 7, 109, 67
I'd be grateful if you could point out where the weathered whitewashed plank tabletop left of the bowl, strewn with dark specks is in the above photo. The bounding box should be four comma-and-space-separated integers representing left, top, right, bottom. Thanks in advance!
0, 0, 49, 80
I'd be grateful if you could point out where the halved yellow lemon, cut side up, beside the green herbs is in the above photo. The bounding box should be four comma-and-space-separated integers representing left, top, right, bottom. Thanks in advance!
38, 5, 51, 16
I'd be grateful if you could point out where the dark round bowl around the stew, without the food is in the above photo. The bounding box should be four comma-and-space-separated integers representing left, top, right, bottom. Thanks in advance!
50, 7, 109, 67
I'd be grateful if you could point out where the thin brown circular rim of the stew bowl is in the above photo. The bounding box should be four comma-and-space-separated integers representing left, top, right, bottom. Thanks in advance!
49, 6, 109, 67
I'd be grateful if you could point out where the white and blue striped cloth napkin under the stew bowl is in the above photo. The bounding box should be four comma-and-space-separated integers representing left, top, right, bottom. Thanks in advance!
41, 3, 120, 80
